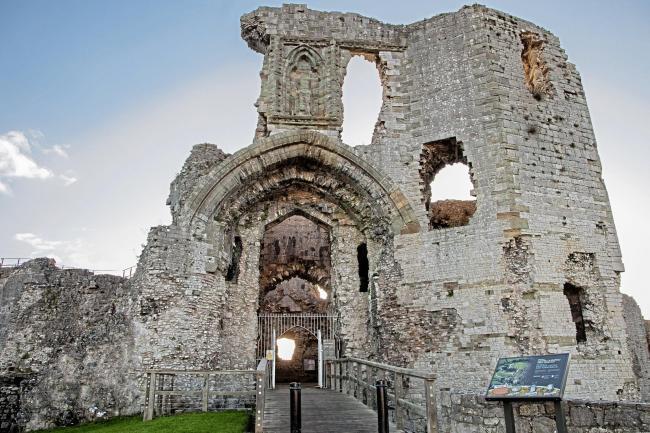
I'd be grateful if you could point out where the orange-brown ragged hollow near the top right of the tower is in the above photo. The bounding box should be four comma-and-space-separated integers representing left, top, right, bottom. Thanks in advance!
521, 32, 551, 100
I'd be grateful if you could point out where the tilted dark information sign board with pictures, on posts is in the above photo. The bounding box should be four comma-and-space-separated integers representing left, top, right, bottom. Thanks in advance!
485, 353, 569, 400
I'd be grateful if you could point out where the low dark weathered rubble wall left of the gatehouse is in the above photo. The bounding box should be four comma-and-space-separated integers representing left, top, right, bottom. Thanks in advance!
0, 259, 141, 431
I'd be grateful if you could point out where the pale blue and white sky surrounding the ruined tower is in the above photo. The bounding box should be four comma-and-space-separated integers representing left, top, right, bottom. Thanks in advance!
0, 0, 650, 318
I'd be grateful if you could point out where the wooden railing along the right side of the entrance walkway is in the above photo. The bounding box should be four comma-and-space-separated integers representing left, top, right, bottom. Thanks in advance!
326, 358, 438, 433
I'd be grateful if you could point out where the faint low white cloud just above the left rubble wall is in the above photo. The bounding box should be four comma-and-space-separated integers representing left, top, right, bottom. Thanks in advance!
14, 233, 90, 267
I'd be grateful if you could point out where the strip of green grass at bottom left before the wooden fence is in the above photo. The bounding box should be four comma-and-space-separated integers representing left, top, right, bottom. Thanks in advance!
38, 411, 249, 433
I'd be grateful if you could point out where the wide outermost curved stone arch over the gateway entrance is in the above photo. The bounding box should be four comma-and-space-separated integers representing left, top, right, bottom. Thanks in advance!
186, 131, 420, 234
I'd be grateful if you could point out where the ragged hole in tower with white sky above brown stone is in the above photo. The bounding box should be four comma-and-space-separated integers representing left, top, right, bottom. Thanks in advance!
420, 137, 476, 229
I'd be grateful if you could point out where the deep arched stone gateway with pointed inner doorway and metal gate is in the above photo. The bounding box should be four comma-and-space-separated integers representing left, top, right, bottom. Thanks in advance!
185, 131, 419, 380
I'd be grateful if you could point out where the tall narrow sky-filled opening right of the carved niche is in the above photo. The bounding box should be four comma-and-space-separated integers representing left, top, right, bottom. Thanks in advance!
341, 54, 383, 146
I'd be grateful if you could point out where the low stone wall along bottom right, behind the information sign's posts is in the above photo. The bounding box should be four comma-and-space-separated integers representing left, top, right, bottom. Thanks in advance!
440, 392, 650, 433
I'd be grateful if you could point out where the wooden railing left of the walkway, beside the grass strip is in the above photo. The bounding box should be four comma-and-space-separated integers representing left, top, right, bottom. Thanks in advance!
143, 359, 271, 433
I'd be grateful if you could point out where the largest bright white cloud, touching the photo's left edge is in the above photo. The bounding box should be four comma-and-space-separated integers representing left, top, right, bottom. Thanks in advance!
0, 131, 53, 188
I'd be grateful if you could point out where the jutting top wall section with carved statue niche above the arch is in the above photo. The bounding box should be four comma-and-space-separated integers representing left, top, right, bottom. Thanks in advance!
241, 4, 406, 137
